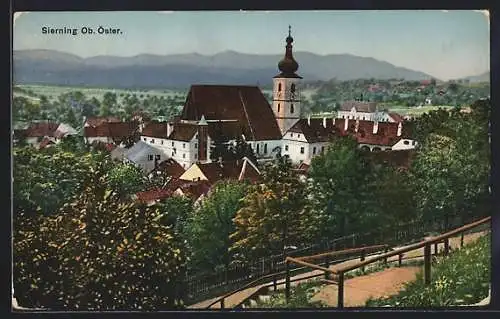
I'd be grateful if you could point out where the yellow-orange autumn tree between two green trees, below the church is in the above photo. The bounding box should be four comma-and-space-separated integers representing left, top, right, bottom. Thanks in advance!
230, 155, 309, 260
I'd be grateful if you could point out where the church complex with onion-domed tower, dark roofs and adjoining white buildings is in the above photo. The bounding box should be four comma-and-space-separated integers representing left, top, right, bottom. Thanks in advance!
140, 27, 416, 169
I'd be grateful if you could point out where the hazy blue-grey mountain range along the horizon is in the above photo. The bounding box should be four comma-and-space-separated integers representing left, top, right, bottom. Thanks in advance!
13, 50, 482, 88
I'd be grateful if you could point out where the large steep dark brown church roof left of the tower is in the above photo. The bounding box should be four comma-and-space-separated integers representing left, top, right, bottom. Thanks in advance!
182, 85, 281, 140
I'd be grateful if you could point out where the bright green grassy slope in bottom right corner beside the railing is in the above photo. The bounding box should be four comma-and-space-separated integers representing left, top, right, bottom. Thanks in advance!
366, 234, 491, 307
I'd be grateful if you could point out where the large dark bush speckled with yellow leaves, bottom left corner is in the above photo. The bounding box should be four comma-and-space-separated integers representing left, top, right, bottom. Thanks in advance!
14, 163, 189, 311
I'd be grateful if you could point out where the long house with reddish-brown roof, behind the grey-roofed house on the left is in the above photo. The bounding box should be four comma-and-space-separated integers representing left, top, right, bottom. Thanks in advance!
83, 122, 139, 145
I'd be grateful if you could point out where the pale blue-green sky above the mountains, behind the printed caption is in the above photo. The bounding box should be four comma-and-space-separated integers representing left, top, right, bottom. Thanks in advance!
13, 10, 490, 80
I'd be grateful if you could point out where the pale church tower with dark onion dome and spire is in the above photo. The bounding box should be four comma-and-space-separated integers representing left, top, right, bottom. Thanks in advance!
273, 26, 302, 135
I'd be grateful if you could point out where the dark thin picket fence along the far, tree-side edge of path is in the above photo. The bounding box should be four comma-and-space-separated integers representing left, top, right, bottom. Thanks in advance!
178, 214, 484, 304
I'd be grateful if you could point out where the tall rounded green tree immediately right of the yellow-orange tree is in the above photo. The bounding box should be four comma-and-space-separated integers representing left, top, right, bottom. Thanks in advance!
307, 137, 370, 241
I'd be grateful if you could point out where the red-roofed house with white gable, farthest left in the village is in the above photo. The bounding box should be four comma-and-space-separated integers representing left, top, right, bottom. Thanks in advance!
23, 121, 77, 147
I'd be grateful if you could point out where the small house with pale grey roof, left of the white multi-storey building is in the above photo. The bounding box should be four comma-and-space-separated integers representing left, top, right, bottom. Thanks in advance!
123, 141, 169, 173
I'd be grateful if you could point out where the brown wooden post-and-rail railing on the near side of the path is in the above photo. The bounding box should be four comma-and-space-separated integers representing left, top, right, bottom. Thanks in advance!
285, 216, 491, 308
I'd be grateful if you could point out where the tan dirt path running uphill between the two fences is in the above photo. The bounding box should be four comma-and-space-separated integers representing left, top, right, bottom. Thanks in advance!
188, 231, 487, 309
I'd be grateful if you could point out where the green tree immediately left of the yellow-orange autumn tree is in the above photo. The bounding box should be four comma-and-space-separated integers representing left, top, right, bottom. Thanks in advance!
186, 181, 247, 270
